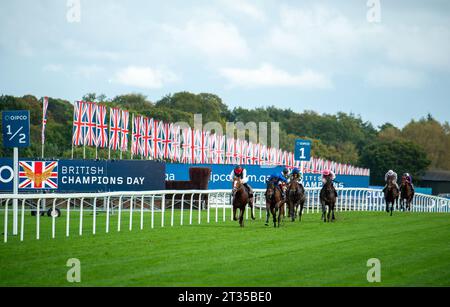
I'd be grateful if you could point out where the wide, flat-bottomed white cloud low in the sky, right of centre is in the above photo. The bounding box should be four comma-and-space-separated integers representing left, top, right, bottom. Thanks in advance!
220, 64, 332, 89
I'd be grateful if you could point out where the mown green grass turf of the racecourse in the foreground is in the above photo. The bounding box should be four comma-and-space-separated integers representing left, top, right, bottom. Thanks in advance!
0, 210, 450, 286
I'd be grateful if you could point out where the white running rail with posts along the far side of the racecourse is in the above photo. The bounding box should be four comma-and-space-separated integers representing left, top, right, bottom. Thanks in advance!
0, 188, 450, 242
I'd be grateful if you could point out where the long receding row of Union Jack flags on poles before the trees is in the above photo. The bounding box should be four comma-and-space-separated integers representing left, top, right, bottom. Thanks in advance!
72, 99, 370, 176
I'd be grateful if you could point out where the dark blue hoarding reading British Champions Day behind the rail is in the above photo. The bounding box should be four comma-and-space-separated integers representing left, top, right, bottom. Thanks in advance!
0, 159, 165, 193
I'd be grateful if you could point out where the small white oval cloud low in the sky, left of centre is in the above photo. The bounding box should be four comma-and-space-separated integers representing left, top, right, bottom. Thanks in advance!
113, 66, 178, 89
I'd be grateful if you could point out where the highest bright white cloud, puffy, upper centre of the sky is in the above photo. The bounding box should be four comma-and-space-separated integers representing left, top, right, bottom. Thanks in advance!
163, 20, 249, 58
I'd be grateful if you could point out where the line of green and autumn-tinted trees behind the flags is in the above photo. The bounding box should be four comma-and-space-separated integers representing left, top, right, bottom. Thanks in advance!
0, 92, 450, 184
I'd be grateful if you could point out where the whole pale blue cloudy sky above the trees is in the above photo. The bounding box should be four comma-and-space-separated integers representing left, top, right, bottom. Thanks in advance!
0, 0, 450, 126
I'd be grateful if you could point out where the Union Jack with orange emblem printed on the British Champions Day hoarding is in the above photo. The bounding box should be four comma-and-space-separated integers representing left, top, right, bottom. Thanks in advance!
19, 161, 58, 189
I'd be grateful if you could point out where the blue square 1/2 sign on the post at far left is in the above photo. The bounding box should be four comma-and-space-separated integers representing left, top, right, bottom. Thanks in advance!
2, 111, 30, 147
